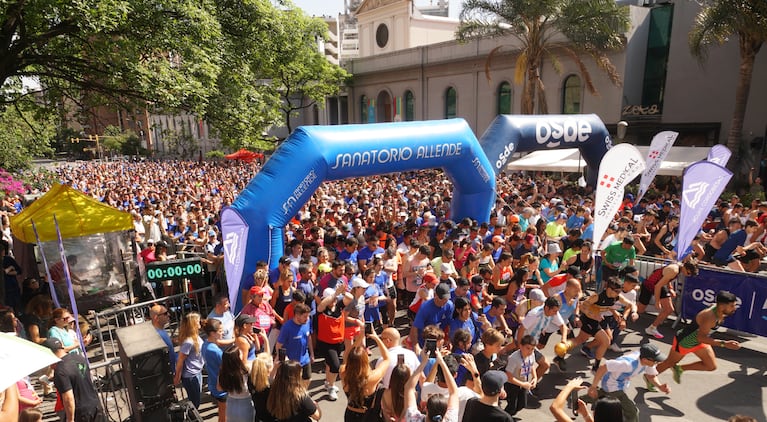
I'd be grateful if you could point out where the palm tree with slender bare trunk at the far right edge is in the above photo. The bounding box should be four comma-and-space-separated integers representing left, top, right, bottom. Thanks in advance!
689, 0, 767, 168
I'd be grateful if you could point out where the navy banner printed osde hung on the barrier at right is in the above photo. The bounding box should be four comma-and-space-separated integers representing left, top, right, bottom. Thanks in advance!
682, 269, 767, 336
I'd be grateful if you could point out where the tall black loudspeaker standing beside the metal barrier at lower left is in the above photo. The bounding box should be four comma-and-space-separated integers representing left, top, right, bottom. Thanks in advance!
115, 322, 176, 422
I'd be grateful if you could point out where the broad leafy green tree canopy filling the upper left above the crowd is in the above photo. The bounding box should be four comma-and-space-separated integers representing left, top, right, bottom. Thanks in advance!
0, 0, 346, 163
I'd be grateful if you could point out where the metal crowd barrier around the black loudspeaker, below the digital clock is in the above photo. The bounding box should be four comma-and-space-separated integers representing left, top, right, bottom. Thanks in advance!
87, 287, 212, 422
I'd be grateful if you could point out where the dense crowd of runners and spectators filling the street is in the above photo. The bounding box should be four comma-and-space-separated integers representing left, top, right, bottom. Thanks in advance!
0, 158, 767, 422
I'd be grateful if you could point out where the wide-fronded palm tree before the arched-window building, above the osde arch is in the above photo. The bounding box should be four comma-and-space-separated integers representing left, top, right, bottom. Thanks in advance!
457, 0, 629, 114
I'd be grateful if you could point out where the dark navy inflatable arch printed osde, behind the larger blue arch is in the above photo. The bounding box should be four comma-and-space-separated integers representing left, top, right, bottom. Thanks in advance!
479, 114, 612, 186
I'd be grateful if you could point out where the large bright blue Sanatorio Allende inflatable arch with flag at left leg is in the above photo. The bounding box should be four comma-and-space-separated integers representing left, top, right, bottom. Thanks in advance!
221, 119, 495, 306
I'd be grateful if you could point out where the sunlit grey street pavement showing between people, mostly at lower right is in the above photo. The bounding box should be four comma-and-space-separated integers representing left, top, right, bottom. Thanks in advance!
41, 315, 767, 422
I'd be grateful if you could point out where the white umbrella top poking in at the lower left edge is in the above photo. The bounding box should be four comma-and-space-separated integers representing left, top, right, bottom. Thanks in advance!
0, 333, 60, 391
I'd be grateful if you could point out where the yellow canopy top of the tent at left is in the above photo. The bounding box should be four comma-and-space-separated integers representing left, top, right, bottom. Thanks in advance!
11, 183, 133, 243
